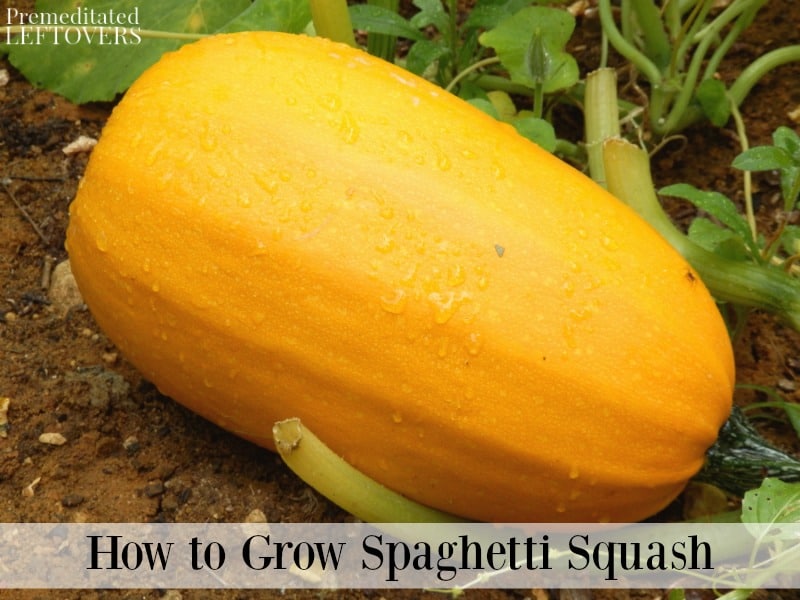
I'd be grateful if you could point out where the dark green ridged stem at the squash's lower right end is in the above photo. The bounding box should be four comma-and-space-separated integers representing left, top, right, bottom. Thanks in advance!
694, 408, 800, 496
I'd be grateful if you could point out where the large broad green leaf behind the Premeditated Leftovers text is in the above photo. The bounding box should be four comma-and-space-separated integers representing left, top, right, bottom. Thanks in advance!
7, 0, 308, 104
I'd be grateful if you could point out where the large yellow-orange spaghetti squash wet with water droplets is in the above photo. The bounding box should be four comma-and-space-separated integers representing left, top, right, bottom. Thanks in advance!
67, 32, 734, 522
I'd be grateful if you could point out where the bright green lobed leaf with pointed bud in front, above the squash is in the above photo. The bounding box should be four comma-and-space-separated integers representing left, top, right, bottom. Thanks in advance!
480, 6, 579, 93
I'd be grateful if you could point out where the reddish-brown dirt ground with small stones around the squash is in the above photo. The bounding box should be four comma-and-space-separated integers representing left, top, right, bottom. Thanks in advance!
0, 0, 800, 599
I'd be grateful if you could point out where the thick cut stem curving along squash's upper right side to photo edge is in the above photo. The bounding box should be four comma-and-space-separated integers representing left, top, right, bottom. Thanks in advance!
604, 139, 800, 331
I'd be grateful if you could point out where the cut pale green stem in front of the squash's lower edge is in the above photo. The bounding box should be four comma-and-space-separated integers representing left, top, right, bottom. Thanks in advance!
272, 419, 464, 523
